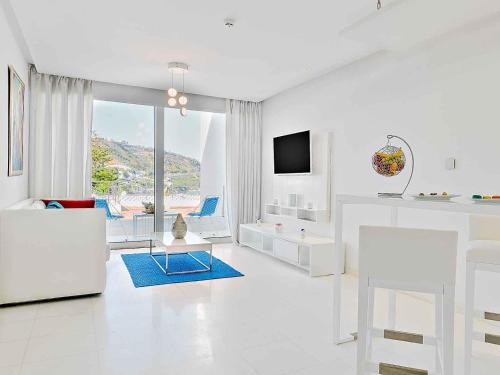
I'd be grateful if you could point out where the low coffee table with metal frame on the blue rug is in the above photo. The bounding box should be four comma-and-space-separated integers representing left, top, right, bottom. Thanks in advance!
147, 232, 212, 276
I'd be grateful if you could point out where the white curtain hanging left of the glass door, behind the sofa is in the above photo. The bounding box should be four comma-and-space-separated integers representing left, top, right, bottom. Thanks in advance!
29, 66, 93, 198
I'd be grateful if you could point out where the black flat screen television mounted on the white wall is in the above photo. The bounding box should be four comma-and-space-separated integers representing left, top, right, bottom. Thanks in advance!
273, 130, 311, 174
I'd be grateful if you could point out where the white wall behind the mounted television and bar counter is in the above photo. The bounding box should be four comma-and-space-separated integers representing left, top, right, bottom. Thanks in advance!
262, 19, 500, 308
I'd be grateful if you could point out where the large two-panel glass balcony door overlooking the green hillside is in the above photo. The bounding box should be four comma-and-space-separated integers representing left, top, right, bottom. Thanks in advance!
92, 100, 228, 239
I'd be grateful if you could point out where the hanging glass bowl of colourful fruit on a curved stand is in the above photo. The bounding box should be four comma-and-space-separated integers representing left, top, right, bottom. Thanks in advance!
372, 135, 414, 198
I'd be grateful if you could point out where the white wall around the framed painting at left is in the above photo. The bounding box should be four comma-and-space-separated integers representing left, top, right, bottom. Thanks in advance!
0, 4, 29, 208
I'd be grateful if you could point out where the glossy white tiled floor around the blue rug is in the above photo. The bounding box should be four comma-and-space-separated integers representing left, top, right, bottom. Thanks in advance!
0, 244, 500, 375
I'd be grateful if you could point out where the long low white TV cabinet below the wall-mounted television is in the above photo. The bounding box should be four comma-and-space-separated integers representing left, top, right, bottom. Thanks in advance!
240, 223, 345, 276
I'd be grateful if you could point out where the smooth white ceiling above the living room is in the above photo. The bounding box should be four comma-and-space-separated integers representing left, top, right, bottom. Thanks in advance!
11, 0, 500, 101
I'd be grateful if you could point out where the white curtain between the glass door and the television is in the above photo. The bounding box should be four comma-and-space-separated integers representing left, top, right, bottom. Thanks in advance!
226, 100, 262, 243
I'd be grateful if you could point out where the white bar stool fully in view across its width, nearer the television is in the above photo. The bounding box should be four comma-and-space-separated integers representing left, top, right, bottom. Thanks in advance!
357, 226, 458, 375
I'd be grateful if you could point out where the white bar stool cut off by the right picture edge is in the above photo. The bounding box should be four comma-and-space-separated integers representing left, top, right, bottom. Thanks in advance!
464, 215, 500, 375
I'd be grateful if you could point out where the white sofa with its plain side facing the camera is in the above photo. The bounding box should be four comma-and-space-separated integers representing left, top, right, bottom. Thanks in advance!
0, 199, 109, 305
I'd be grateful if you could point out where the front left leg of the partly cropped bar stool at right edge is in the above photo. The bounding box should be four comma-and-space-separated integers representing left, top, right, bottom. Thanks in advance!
464, 262, 476, 375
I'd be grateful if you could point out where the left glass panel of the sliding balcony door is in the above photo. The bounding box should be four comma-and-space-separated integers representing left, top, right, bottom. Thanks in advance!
92, 100, 155, 239
